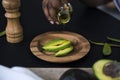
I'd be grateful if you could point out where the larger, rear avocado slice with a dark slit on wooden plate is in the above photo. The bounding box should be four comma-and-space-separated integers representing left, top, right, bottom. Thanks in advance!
42, 39, 71, 52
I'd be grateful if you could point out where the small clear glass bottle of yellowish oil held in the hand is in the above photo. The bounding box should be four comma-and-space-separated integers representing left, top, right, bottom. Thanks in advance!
57, 3, 73, 24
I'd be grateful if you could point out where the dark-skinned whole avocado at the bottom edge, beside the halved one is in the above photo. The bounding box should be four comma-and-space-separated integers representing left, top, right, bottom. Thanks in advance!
59, 69, 93, 80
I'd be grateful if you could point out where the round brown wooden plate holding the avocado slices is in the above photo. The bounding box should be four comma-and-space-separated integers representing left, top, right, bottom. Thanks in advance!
30, 31, 90, 63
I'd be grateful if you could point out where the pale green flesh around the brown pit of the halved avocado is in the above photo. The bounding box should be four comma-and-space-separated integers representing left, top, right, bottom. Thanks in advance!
93, 59, 120, 80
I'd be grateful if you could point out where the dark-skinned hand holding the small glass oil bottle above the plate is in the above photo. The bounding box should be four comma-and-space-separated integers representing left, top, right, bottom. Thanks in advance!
42, 0, 68, 24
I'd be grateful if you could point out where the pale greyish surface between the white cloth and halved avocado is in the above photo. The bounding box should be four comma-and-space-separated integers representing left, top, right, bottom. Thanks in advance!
28, 68, 93, 80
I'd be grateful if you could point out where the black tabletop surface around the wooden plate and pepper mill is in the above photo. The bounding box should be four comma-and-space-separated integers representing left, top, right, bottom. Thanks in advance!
0, 0, 120, 67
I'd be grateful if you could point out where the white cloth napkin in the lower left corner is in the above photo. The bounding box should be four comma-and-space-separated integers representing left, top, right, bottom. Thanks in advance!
0, 65, 44, 80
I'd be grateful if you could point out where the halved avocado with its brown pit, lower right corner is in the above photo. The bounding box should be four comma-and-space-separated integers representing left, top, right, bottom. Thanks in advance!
93, 59, 120, 80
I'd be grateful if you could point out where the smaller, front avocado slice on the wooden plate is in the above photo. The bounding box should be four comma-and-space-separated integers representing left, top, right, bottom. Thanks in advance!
55, 46, 73, 57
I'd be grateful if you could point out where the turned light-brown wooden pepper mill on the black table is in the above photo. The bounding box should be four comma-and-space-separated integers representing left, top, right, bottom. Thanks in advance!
2, 0, 23, 43
